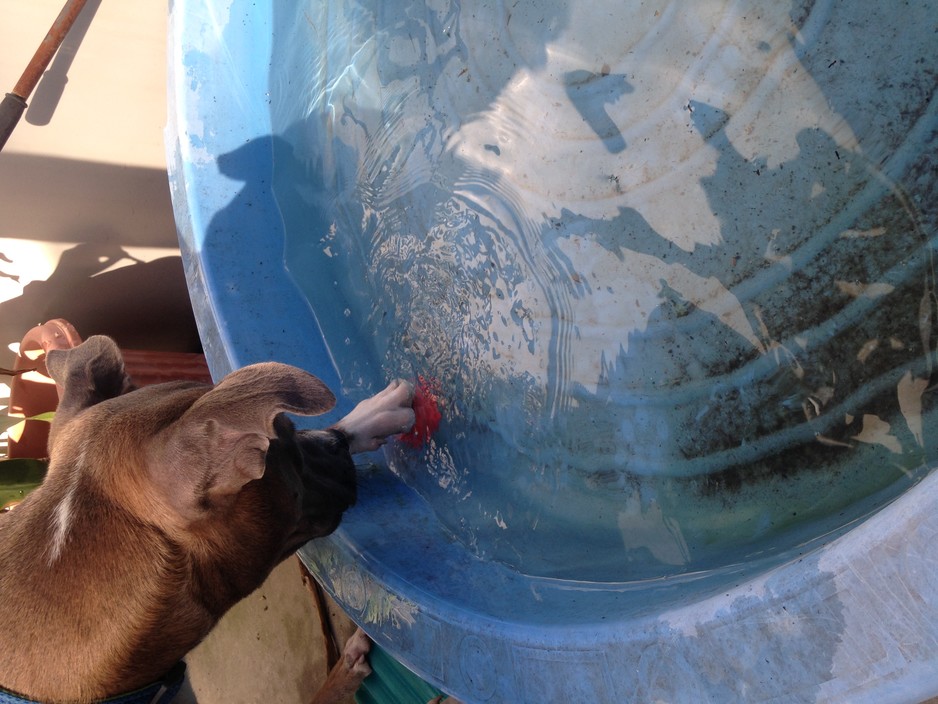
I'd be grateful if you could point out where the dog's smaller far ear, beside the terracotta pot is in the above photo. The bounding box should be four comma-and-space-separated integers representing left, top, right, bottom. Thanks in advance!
46, 335, 133, 424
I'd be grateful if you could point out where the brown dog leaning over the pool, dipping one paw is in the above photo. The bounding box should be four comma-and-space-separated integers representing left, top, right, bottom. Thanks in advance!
0, 337, 414, 702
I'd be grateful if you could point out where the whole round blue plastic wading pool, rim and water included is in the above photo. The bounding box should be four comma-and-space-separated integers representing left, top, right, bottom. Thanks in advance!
168, 0, 938, 702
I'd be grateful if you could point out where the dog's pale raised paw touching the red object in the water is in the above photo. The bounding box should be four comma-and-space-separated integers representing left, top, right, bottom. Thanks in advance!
335, 379, 414, 454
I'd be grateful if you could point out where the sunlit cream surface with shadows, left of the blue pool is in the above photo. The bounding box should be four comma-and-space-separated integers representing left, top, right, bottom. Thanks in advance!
0, 0, 198, 374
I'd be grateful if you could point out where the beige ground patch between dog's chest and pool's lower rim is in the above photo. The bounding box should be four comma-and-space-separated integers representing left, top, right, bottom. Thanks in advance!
174, 557, 355, 704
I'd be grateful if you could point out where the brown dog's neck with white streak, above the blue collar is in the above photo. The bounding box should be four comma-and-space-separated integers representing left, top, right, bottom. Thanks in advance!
0, 472, 215, 701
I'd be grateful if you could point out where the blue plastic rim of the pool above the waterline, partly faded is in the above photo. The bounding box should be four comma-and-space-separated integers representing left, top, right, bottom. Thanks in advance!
166, 0, 938, 704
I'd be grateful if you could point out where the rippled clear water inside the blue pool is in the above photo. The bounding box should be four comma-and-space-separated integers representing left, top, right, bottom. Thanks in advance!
269, 0, 938, 582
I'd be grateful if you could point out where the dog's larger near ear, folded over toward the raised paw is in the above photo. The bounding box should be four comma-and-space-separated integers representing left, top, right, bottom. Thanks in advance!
159, 362, 335, 500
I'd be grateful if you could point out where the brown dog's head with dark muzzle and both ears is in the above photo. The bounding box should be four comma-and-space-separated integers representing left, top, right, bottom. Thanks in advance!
46, 336, 355, 552
